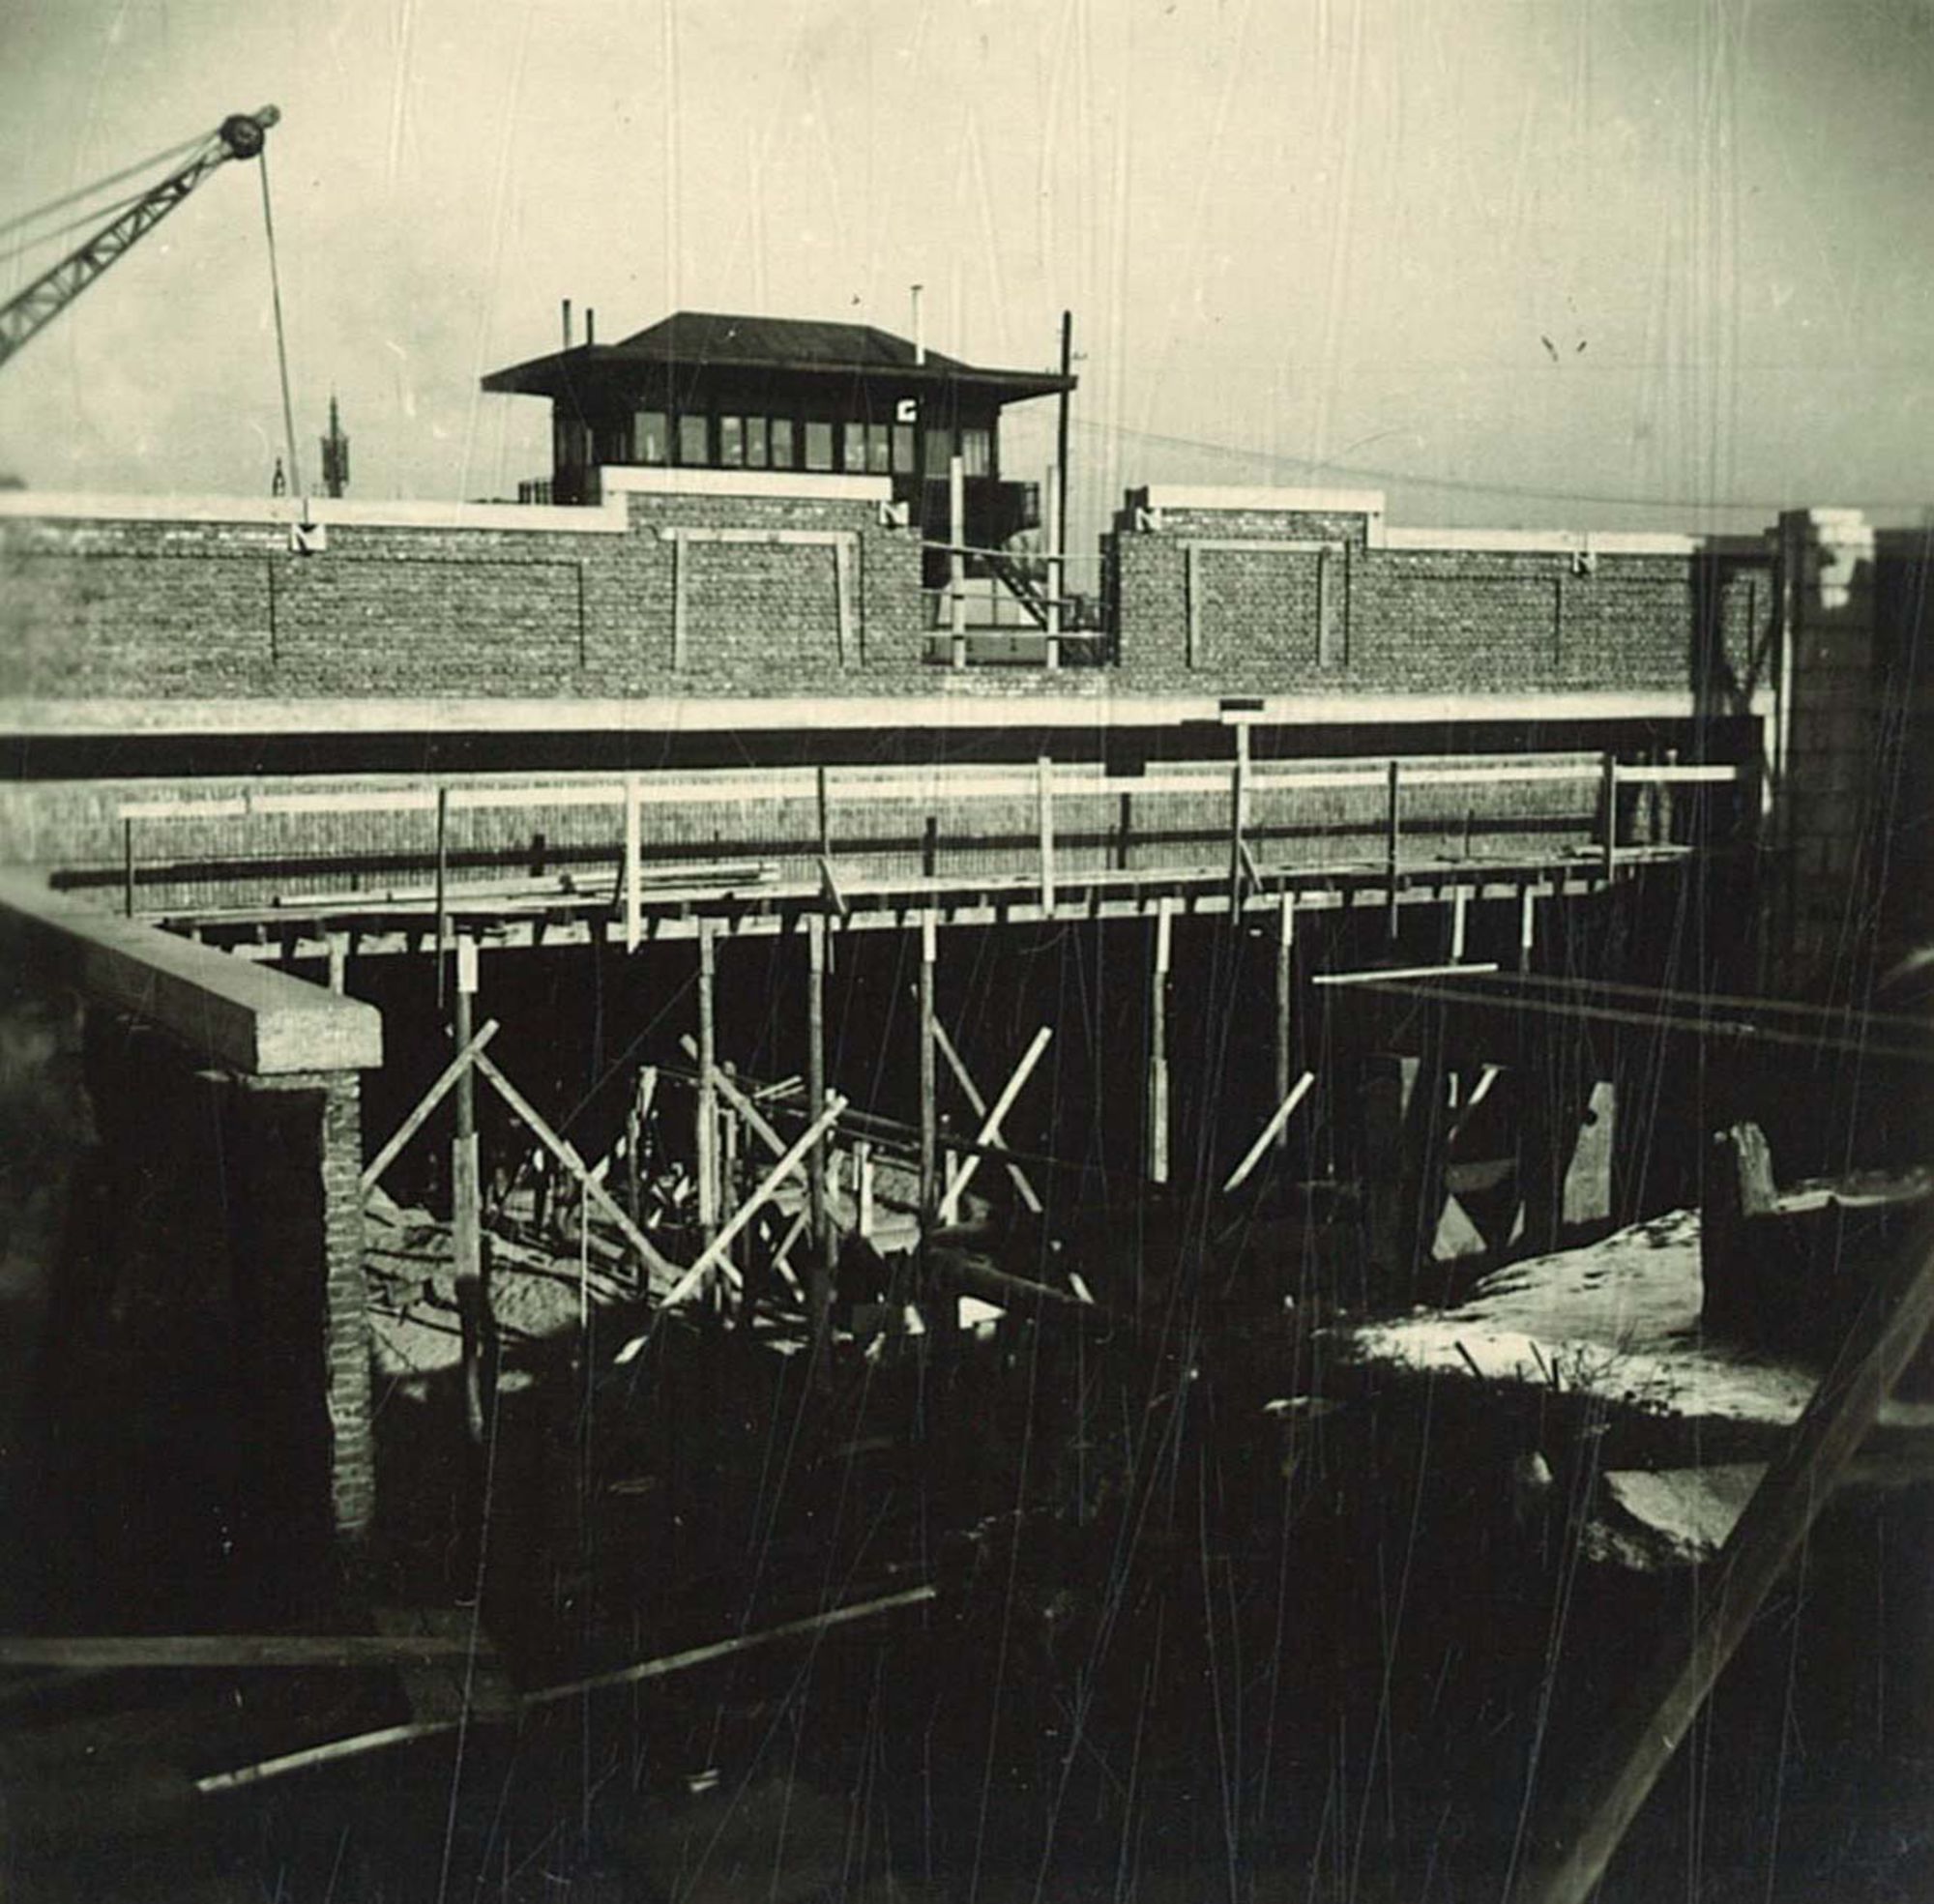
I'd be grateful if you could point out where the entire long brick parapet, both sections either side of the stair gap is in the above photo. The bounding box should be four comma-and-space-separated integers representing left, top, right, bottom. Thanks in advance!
0, 472, 1772, 700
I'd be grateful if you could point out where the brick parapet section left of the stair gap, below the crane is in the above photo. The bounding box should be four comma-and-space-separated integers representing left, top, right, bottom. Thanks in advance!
0, 480, 921, 698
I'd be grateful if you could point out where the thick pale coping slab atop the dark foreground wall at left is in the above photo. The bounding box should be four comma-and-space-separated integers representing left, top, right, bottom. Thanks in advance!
0, 868, 383, 1078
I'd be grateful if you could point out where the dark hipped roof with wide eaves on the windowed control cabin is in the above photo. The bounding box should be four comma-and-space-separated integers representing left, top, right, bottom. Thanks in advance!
484, 311, 1075, 404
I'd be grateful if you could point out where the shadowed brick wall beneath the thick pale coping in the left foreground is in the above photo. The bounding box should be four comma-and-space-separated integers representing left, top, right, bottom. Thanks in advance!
29, 1011, 375, 1629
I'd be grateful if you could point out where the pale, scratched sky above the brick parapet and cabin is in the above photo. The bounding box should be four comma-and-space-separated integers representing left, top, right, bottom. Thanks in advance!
0, 0, 1934, 536
